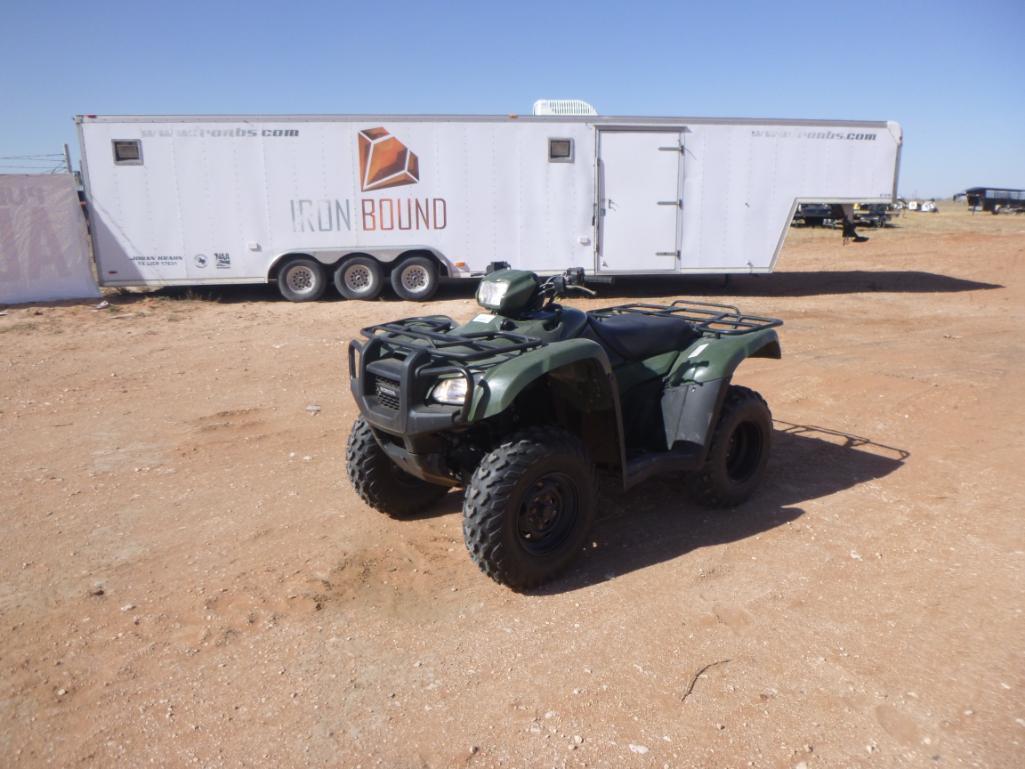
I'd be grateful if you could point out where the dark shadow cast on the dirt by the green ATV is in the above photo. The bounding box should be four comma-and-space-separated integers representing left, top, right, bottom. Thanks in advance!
535, 420, 909, 595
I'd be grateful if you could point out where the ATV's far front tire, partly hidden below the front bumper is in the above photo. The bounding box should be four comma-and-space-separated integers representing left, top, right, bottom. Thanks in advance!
345, 416, 448, 518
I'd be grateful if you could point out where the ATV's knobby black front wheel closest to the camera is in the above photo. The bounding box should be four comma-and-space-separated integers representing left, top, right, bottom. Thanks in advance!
462, 428, 596, 590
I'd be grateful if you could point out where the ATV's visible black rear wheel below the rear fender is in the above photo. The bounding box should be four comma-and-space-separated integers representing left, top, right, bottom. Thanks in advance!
688, 386, 772, 508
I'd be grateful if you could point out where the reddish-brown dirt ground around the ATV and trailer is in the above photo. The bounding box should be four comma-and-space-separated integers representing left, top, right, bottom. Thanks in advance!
6, 203, 1025, 769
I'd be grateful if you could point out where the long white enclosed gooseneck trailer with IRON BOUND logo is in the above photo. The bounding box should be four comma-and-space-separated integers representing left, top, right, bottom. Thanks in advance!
76, 110, 901, 299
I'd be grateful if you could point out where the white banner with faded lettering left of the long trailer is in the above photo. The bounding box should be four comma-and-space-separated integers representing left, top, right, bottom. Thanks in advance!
0, 173, 99, 305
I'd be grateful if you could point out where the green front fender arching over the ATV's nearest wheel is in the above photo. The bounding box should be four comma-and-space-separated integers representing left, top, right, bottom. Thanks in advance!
467, 339, 615, 422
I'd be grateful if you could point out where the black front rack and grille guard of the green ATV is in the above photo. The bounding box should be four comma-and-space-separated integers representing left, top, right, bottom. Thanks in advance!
349, 315, 546, 435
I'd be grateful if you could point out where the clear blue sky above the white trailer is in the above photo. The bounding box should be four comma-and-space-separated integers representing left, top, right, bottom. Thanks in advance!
0, 0, 1025, 196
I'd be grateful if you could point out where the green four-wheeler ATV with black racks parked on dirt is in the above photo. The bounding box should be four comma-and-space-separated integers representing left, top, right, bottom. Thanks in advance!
346, 269, 782, 590
